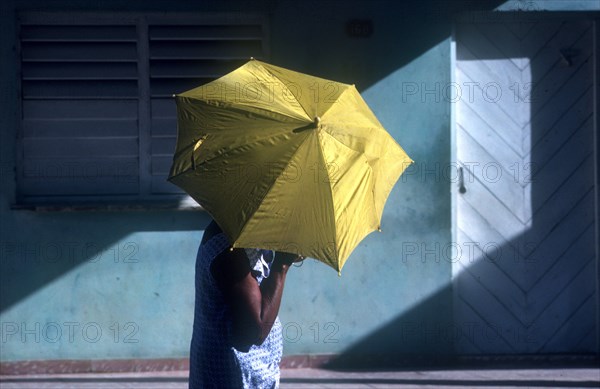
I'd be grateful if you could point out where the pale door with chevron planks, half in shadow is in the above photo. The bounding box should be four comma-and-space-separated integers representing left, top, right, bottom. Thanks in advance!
453, 19, 598, 354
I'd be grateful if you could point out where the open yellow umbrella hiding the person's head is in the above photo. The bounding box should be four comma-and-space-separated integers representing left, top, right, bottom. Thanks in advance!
169, 59, 412, 272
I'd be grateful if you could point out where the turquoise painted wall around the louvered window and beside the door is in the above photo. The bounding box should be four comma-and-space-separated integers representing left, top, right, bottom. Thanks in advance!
0, 0, 600, 361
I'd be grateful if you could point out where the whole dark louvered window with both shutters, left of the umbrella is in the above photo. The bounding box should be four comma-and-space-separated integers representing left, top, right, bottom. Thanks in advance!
17, 13, 267, 205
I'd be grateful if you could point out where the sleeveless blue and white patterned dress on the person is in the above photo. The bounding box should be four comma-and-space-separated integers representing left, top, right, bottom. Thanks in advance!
189, 233, 283, 389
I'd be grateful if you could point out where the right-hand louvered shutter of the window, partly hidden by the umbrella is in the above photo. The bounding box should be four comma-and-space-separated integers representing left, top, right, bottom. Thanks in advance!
148, 18, 266, 194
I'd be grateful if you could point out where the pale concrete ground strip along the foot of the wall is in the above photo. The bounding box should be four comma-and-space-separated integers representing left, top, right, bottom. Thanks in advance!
0, 368, 600, 389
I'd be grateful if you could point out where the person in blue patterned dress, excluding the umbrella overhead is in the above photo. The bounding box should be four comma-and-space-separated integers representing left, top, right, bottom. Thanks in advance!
189, 221, 304, 389
